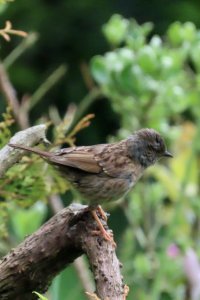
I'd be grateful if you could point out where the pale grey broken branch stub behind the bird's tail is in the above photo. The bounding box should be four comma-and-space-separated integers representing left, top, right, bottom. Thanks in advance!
0, 125, 46, 178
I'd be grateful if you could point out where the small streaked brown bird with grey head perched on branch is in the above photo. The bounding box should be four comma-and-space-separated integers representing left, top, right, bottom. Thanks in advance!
9, 128, 172, 244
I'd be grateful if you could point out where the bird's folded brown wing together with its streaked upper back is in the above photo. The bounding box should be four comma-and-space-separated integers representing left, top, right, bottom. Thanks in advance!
48, 141, 130, 177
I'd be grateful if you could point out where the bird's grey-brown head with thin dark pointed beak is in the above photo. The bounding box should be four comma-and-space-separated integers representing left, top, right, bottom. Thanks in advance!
127, 128, 173, 168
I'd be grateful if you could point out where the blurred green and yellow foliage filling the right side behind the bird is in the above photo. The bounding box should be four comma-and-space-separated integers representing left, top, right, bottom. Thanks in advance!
91, 15, 200, 300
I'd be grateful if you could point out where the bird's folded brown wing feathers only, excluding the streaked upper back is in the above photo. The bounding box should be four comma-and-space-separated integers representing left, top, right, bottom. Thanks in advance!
48, 145, 106, 174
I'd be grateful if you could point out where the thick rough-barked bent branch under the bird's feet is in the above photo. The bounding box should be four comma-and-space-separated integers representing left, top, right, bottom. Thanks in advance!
0, 205, 125, 300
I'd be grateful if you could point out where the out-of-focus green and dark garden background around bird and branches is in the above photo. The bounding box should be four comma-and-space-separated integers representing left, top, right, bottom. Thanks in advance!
0, 0, 200, 300
